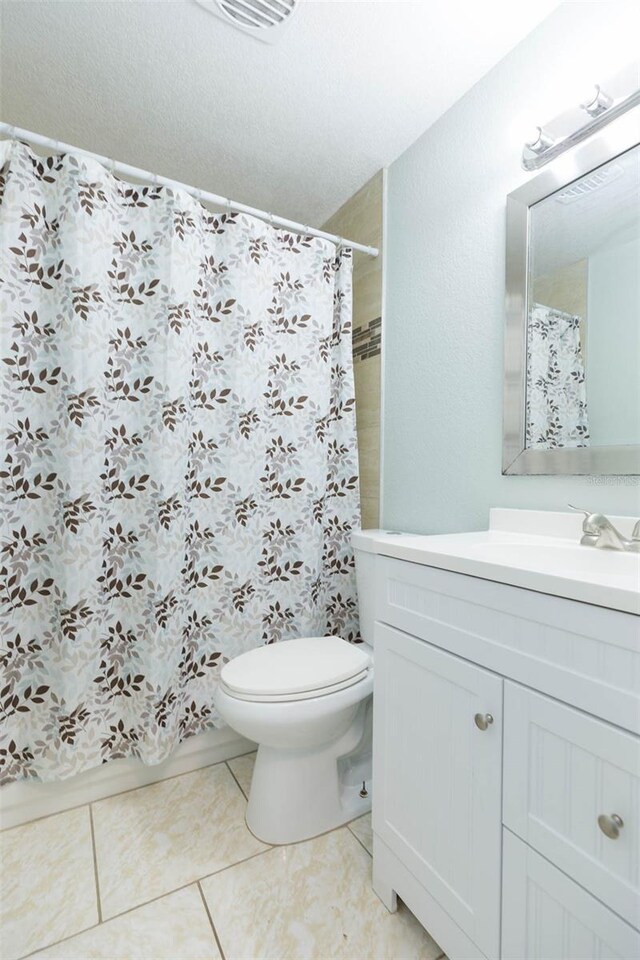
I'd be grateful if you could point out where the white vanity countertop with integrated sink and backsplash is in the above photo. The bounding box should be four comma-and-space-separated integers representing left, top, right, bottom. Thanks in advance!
355, 509, 640, 614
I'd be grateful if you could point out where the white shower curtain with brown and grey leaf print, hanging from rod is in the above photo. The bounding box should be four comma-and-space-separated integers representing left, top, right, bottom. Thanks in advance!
0, 142, 359, 781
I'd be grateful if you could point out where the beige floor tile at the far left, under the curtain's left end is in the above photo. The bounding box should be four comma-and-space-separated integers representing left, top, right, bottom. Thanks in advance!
0, 807, 98, 960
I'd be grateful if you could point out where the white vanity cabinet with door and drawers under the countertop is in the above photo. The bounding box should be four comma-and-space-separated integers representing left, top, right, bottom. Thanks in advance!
373, 556, 640, 960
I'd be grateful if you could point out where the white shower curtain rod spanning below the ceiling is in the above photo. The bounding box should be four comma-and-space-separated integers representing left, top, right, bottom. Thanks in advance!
0, 122, 379, 257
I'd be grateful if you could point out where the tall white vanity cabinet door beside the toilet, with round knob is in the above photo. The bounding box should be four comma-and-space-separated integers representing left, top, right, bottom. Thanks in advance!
373, 623, 502, 957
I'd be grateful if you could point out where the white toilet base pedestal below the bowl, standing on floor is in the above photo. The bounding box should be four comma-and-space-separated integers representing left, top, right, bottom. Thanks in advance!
246, 703, 371, 845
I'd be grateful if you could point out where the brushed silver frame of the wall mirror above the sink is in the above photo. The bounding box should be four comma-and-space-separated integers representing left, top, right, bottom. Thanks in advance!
502, 106, 640, 476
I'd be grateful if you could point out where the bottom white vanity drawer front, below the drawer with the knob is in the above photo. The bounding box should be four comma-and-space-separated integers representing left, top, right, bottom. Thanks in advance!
502, 830, 640, 960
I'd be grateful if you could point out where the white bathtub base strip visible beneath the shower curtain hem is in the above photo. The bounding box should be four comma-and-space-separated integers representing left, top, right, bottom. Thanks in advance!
0, 727, 256, 830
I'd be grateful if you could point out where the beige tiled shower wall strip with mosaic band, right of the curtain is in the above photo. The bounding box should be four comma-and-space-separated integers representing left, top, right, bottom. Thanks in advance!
324, 171, 383, 527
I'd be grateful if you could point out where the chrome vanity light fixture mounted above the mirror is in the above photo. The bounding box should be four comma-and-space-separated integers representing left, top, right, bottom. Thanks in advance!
522, 63, 640, 170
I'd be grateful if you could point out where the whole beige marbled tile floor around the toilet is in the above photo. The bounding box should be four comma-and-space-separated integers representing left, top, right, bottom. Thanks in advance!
0, 754, 446, 960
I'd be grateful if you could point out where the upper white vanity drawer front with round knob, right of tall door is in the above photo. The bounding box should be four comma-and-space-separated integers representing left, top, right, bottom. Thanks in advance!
503, 682, 640, 927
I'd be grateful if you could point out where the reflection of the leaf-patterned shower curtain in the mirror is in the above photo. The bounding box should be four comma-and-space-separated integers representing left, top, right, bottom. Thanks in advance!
526, 303, 589, 450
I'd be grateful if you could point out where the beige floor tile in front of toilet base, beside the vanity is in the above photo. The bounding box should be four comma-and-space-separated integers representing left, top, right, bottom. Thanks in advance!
202, 827, 441, 960
